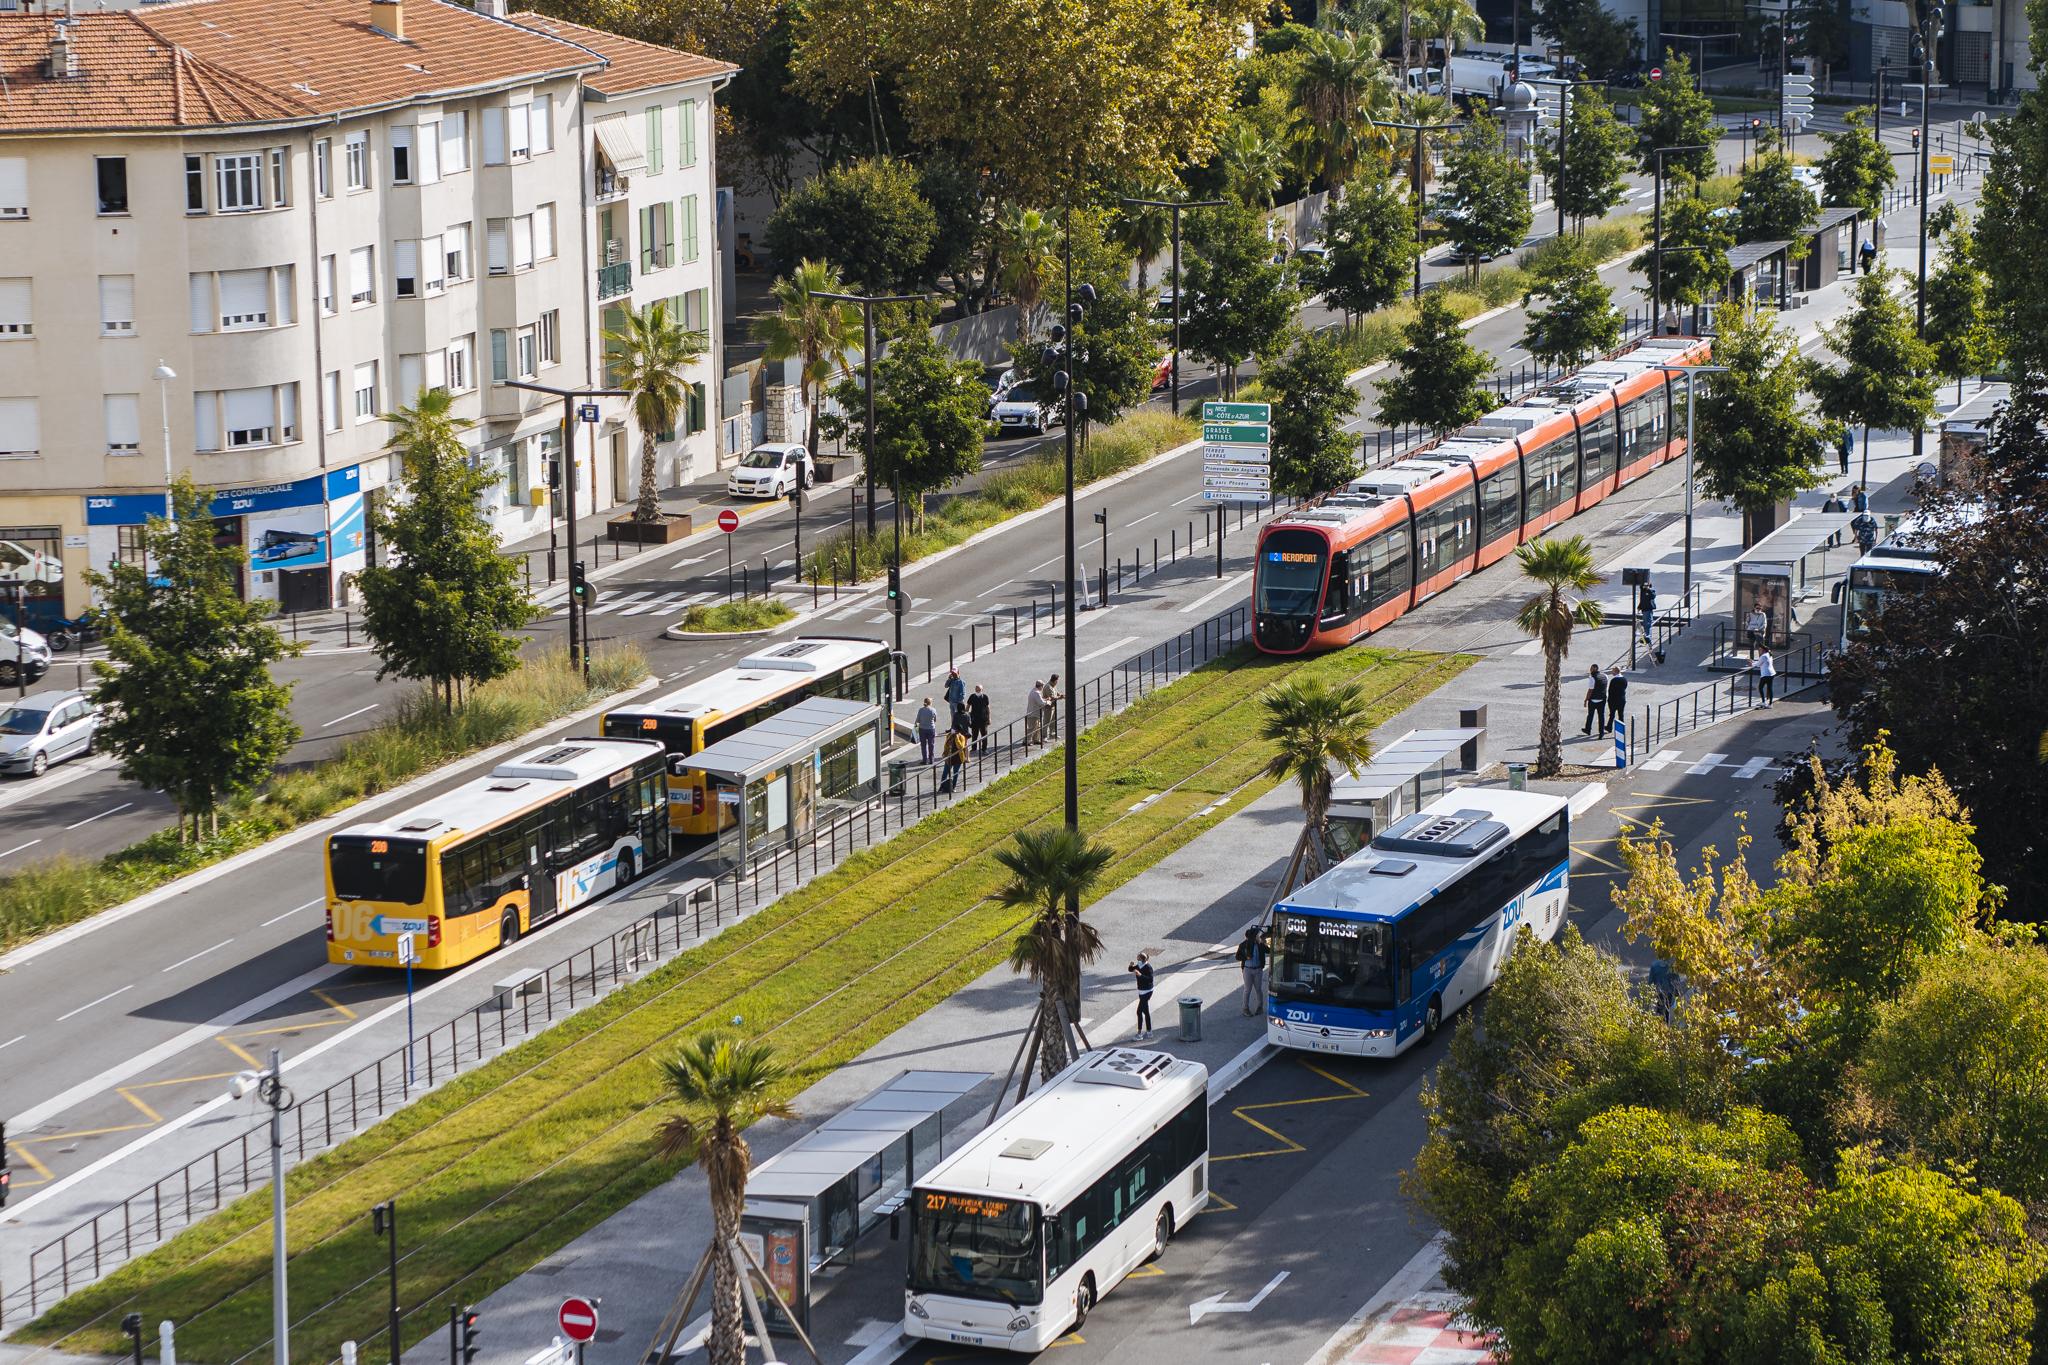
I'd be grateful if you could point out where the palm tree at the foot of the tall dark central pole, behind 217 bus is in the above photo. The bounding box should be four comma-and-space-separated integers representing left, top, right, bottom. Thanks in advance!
995, 825, 1110, 1081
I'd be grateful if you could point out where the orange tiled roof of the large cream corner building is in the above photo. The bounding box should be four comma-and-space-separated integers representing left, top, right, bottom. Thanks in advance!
0, 0, 602, 133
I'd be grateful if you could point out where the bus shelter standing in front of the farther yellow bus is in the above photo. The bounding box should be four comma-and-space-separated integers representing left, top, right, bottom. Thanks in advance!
682, 696, 889, 866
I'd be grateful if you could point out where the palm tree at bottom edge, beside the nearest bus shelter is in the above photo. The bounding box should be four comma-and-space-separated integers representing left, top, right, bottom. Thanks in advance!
655, 1031, 797, 1365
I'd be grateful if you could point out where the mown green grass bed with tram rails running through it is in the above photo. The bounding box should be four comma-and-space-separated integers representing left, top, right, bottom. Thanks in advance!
23, 649, 1468, 1361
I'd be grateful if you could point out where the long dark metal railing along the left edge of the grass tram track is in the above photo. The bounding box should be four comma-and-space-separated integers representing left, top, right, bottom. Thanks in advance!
0, 604, 1251, 1328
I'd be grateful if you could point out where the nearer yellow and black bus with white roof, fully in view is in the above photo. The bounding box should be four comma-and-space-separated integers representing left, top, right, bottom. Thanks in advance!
328, 739, 670, 970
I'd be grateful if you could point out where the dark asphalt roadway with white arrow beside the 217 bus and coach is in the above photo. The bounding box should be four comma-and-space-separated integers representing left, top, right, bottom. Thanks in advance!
903, 702, 1827, 1365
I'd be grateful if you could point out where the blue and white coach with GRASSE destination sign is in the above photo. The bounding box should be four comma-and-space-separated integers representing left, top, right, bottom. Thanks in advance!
1266, 788, 1571, 1056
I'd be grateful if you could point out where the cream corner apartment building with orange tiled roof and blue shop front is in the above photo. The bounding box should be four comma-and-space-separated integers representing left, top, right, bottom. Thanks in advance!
0, 0, 729, 622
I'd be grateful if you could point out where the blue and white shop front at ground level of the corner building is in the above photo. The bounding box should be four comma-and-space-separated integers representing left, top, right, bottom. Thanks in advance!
86, 467, 369, 612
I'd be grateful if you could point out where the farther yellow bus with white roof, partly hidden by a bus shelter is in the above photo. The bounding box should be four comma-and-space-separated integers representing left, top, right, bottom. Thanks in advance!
598, 634, 889, 835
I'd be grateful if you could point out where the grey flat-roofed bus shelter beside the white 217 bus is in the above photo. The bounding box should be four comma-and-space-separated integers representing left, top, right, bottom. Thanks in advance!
739, 1070, 989, 1332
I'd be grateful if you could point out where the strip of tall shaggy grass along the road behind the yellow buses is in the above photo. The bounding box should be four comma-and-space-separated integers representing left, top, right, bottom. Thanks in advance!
0, 645, 647, 950
